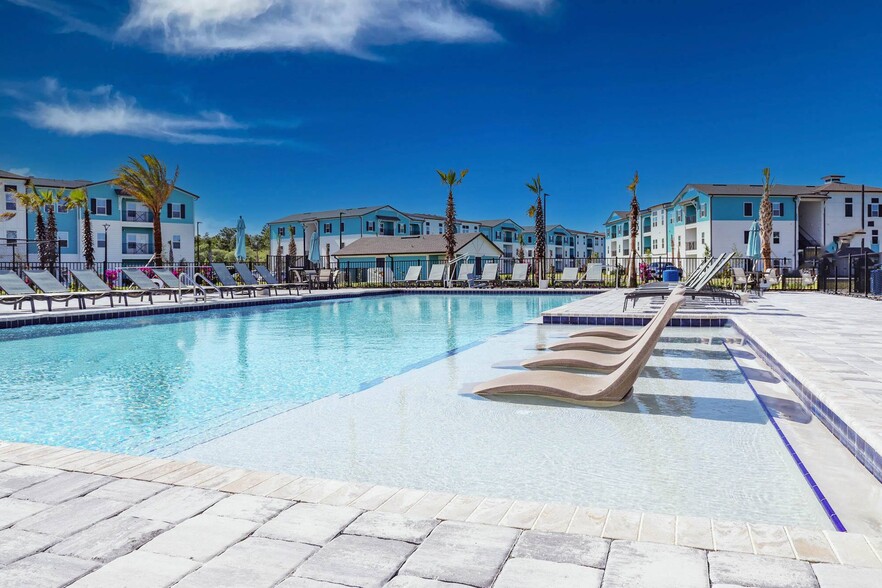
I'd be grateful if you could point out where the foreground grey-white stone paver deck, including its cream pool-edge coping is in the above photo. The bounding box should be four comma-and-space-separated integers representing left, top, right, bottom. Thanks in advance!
0, 443, 882, 588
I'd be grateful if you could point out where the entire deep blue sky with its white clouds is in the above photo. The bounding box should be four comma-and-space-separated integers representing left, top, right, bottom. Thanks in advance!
0, 0, 882, 232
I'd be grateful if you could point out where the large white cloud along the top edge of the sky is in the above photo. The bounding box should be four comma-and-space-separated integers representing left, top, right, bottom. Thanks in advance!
120, 0, 551, 56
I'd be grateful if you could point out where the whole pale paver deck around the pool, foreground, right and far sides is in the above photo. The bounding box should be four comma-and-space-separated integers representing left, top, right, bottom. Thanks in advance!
0, 289, 882, 588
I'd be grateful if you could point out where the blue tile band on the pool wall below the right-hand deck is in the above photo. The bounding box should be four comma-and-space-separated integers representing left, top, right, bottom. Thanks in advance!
733, 323, 882, 482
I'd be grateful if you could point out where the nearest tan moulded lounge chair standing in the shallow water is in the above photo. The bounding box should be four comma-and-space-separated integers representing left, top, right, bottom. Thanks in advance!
473, 291, 685, 407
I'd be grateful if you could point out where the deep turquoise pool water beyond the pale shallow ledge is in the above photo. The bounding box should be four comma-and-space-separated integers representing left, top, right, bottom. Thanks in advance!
0, 295, 576, 456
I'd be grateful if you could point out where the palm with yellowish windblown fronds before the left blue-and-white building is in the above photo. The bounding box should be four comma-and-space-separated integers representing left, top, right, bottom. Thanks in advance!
113, 155, 180, 263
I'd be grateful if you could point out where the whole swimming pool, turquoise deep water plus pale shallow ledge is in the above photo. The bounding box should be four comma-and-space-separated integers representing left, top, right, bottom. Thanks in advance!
0, 294, 831, 528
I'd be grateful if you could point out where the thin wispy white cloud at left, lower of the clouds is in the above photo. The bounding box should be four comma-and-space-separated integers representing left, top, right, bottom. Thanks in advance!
7, 78, 278, 145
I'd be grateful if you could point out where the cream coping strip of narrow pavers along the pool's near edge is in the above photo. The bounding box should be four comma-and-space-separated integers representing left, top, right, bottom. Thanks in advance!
0, 441, 882, 569
